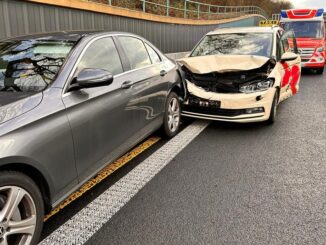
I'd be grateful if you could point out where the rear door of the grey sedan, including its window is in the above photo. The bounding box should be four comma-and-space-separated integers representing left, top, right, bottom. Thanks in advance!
117, 35, 168, 137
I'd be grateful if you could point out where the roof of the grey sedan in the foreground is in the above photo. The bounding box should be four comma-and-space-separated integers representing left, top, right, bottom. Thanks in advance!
1, 31, 138, 42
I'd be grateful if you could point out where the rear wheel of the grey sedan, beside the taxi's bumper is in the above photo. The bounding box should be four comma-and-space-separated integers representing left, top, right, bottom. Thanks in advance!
162, 92, 181, 138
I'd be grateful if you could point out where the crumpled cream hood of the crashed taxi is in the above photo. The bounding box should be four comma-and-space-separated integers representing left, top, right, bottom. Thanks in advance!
178, 55, 270, 74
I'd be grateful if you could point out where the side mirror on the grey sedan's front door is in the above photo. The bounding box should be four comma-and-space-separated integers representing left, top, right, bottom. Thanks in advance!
76, 69, 113, 88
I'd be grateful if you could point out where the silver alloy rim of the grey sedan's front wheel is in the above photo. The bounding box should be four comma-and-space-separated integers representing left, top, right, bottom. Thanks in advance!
0, 186, 36, 245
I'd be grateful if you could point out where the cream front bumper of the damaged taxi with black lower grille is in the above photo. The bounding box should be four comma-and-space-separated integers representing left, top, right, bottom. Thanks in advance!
182, 87, 276, 123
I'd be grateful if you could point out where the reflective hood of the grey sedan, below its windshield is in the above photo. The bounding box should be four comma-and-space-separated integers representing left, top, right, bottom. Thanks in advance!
0, 92, 43, 124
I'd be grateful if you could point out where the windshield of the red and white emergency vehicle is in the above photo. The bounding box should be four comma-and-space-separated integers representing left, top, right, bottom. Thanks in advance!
284, 21, 324, 38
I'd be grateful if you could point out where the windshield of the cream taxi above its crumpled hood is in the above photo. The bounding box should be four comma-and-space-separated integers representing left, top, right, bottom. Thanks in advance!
191, 33, 273, 57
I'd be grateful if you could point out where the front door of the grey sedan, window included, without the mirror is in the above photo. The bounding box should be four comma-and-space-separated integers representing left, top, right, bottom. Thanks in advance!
63, 37, 139, 180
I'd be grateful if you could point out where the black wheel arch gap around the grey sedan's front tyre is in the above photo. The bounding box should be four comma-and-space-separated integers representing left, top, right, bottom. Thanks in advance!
0, 163, 52, 212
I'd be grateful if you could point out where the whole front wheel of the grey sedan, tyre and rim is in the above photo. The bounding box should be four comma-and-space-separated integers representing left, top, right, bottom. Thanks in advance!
0, 171, 44, 245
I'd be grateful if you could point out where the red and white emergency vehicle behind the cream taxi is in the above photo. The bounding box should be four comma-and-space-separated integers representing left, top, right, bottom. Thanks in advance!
280, 9, 326, 74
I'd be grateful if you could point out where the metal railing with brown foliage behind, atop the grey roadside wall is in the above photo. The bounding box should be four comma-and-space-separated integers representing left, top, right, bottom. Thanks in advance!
88, 0, 268, 20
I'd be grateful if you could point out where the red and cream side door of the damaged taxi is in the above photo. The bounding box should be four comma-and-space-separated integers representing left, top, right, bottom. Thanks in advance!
279, 31, 301, 99
